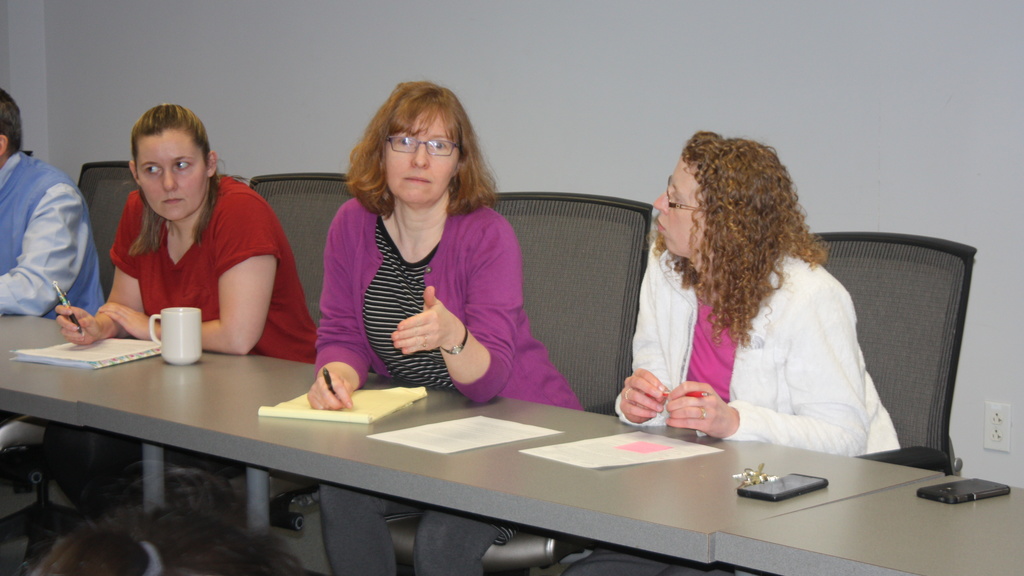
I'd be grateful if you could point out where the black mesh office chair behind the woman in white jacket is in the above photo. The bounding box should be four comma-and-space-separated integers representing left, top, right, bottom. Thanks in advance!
820, 233, 977, 475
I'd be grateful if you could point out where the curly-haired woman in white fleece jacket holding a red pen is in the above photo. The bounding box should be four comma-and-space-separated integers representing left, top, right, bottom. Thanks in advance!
566, 132, 899, 576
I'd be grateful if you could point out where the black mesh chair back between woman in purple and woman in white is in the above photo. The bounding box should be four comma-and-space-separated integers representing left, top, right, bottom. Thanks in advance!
496, 193, 651, 414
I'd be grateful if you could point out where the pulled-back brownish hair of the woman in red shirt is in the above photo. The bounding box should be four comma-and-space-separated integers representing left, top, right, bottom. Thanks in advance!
128, 104, 220, 256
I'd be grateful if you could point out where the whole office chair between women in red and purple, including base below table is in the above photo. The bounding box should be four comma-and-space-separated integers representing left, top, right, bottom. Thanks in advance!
249, 172, 351, 530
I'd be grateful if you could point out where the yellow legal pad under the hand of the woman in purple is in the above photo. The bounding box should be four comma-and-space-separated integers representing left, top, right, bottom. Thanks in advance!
259, 386, 427, 424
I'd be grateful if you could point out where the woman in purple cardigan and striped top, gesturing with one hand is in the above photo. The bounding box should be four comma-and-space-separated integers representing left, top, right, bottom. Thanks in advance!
308, 82, 580, 576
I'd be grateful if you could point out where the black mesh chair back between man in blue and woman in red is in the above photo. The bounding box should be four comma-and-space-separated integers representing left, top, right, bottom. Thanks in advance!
78, 161, 138, 298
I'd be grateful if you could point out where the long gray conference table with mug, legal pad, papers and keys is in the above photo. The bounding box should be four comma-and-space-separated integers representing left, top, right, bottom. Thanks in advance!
0, 317, 938, 569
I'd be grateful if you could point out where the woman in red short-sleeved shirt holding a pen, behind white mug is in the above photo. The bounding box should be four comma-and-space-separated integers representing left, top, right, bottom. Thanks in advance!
57, 105, 316, 363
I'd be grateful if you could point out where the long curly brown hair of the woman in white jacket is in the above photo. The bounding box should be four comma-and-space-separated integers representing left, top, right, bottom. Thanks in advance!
654, 132, 828, 345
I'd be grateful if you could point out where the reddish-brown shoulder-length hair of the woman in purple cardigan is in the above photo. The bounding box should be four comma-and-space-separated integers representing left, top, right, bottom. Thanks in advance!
346, 82, 498, 217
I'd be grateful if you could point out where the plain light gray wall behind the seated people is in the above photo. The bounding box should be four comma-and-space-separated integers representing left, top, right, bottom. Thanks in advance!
0, 0, 1024, 486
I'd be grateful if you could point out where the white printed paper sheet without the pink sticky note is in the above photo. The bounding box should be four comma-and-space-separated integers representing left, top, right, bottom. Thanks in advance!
367, 416, 562, 454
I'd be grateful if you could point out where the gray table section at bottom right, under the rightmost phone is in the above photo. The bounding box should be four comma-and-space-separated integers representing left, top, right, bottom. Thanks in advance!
715, 477, 1024, 576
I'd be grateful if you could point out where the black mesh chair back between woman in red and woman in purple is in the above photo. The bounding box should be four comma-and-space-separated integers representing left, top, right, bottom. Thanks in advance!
249, 172, 351, 325
